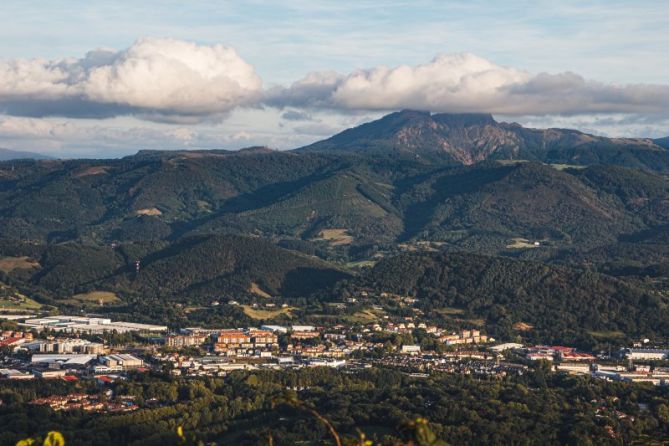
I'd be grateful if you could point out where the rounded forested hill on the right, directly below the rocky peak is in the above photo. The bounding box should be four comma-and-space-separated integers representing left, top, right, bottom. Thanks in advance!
397, 163, 669, 253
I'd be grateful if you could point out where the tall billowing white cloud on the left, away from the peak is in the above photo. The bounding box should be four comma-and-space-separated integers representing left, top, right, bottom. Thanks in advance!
0, 39, 262, 122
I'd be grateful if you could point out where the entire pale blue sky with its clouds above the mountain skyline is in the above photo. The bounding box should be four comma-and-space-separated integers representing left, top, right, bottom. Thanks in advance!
0, 0, 669, 158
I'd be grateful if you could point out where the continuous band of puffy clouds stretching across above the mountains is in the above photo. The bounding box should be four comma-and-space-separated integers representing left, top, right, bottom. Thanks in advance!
0, 39, 669, 123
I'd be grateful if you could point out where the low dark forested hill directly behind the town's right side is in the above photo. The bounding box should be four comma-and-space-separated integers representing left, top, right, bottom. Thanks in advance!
357, 253, 669, 345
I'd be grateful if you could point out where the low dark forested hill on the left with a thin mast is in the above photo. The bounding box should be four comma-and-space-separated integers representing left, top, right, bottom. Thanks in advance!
0, 236, 350, 304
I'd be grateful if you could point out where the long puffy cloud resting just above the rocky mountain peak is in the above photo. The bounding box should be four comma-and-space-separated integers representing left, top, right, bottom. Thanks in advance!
265, 53, 669, 115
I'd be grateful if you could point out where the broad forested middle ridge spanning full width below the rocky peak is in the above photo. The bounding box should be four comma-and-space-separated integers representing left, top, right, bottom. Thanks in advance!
0, 149, 669, 264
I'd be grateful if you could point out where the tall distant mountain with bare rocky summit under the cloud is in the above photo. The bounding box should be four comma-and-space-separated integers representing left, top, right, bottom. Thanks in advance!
298, 110, 669, 170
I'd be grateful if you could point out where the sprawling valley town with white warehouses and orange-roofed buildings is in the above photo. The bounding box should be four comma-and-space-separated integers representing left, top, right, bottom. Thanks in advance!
0, 315, 669, 412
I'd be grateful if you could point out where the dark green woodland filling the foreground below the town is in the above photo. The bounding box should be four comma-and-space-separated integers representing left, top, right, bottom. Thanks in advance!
0, 366, 669, 446
